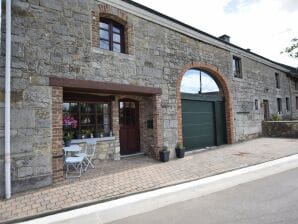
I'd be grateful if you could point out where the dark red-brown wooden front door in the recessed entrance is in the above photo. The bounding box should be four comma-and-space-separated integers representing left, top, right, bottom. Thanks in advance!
119, 100, 140, 155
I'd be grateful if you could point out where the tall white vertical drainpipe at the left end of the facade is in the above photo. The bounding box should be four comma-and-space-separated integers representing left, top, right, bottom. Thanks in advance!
1, 0, 11, 199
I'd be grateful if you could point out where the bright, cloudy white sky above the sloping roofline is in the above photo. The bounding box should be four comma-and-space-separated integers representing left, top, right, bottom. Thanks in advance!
134, 0, 298, 67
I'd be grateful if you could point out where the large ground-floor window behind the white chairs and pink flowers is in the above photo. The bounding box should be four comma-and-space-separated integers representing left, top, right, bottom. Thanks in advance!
63, 102, 111, 137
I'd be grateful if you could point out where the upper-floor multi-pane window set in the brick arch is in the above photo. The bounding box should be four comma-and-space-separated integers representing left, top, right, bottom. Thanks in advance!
99, 19, 124, 53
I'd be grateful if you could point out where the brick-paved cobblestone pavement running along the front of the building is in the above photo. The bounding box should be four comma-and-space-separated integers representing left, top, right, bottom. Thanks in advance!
0, 138, 298, 223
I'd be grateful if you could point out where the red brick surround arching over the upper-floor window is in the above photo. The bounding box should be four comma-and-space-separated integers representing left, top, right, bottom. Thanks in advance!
91, 3, 134, 54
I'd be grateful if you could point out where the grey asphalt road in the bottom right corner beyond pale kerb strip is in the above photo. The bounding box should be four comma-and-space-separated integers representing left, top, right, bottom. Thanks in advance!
111, 169, 298, 224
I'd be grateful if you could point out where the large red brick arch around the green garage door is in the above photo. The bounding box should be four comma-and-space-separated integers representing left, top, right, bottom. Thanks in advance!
176, 62, 234, 144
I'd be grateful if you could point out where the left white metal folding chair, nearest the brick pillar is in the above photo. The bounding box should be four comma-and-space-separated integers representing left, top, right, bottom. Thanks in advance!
63, 145, 85, 178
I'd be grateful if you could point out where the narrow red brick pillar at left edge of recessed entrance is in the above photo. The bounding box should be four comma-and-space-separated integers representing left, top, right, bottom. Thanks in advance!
52, 86, 63, 182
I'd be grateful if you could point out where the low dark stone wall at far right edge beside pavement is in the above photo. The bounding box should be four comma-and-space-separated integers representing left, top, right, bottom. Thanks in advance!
262, 121, 298, 138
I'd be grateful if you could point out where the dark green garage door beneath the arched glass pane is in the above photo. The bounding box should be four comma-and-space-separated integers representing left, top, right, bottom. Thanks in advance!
181, 93, 226, 150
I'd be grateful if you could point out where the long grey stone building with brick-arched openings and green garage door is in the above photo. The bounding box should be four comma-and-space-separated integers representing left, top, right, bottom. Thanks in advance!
0, 0, 298, 194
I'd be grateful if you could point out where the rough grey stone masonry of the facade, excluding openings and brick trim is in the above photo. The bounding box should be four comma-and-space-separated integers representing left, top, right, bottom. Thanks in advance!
0, 0, 297, 194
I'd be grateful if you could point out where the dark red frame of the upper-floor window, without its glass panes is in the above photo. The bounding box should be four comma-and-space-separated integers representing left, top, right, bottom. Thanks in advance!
98, 18, 125, 53
